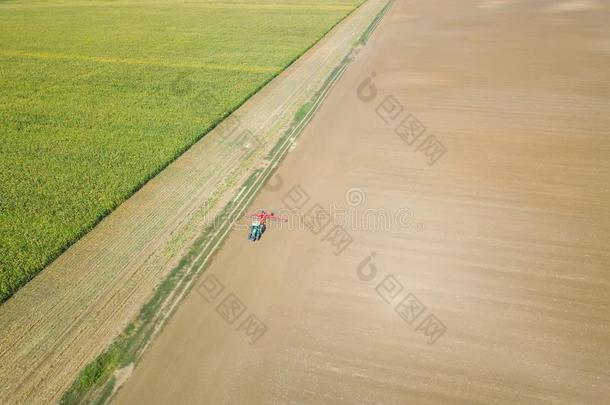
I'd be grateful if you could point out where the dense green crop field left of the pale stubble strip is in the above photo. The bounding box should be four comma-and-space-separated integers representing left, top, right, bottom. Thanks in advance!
0, 0, 362, 302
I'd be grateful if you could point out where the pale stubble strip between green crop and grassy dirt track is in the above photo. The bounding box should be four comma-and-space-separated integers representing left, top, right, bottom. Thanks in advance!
0, 0, 386, 403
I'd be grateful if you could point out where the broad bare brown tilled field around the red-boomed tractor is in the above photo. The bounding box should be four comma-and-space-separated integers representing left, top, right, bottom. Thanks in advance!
116, 0, 610, 404
